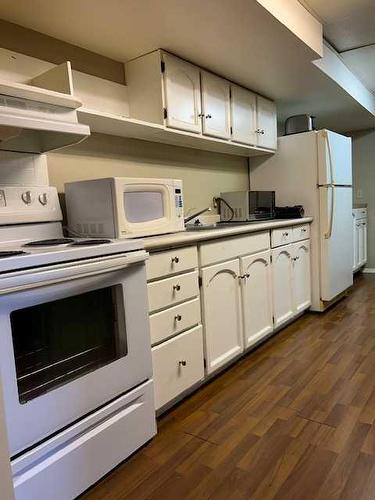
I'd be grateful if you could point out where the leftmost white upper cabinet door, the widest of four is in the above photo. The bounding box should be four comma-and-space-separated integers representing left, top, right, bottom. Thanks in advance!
163, 54, 202, 133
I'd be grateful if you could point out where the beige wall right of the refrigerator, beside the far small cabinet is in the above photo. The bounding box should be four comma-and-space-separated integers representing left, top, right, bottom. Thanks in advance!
352, 130, 375, 268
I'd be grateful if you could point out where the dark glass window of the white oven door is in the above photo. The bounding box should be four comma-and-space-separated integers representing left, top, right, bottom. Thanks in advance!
10, 285, 127, 403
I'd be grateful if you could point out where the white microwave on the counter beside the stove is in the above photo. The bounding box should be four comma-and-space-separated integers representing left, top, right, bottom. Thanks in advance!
65, 177, 185, 238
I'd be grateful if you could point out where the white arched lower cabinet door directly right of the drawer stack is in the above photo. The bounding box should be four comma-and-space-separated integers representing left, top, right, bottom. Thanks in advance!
201, 259, 243, 373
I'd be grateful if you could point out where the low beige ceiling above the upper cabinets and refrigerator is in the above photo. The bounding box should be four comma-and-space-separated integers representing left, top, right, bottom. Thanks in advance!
0, 0, 374, 131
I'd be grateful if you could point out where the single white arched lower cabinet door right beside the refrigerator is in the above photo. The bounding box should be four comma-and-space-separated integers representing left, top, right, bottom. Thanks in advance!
292, 240, 311, 314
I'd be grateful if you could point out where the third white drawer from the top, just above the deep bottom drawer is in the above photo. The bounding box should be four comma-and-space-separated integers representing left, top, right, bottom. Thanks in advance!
150, 297, 201, 345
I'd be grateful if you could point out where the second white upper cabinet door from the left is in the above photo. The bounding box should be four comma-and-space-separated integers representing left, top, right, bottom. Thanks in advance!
201, 71, 230, 139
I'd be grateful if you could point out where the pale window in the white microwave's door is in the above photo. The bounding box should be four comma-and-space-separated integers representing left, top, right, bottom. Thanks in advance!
124, 191, 165, 223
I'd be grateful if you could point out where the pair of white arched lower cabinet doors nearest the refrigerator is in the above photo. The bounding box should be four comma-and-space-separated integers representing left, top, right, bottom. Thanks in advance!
272, 240, 311, 328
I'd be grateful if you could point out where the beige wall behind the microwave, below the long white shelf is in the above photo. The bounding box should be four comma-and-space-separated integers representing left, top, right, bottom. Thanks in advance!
48, 134, 248, 212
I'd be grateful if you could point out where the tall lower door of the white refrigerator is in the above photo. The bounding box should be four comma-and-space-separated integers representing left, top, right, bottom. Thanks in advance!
319, 186, 353, 301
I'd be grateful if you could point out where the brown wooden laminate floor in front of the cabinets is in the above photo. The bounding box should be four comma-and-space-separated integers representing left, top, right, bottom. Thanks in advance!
84, 275, 375, 500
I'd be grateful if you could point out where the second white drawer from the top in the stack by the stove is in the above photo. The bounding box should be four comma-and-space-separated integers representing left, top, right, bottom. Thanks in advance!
147, 271, 199, 312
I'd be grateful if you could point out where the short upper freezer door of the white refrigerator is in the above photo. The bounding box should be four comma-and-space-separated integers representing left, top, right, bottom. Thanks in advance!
318, 130, 353, 186
